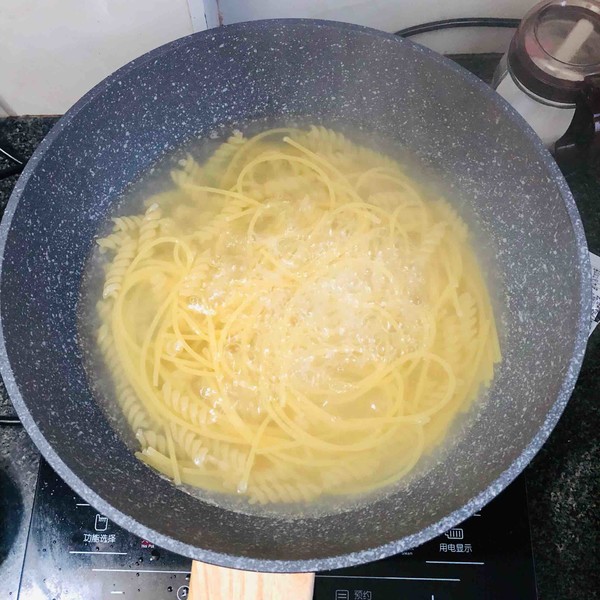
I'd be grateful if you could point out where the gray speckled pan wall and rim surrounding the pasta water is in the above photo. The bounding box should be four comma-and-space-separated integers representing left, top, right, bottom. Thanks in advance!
0, 21, 590, 571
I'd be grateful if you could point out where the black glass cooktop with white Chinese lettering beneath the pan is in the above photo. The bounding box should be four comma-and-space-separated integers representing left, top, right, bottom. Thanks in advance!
18, 460, 537, 600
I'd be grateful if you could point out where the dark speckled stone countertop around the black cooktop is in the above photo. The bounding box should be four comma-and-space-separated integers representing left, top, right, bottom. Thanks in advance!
0, 55, 600, 600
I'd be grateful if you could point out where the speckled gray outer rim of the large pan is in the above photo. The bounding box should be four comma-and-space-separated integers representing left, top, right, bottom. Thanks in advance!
0, 19, 591, 572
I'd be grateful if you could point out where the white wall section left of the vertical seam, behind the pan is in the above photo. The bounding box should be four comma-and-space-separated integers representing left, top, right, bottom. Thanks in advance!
0, 0, 206, 114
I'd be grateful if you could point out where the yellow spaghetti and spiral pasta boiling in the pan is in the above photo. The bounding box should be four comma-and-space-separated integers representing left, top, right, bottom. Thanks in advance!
97, 127, 500, 504
